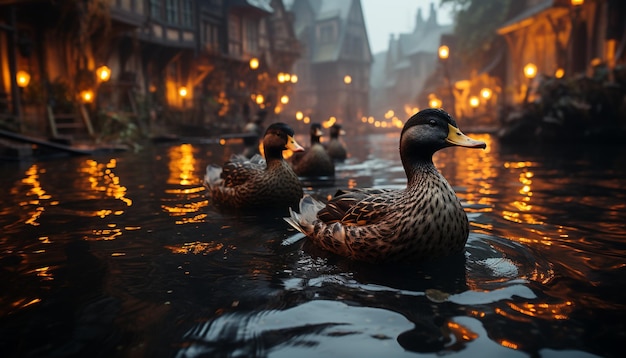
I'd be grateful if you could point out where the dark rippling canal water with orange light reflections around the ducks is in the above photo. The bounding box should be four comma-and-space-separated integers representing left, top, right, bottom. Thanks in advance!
0, 134, 626, 357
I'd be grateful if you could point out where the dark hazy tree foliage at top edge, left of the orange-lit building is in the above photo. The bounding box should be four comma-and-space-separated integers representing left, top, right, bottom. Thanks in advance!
441, 0, 521, 68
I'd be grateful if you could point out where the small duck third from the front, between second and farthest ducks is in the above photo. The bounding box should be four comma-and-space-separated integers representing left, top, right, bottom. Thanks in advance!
292, 123, 335, 178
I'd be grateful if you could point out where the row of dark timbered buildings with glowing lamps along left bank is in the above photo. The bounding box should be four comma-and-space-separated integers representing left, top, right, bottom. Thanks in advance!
0, 0, 300, 143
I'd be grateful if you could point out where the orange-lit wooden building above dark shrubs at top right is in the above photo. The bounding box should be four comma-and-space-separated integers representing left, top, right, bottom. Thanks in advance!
498, 0, 626, 105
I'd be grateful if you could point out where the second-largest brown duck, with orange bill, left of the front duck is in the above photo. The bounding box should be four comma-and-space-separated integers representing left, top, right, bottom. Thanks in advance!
204, 122, 304, 212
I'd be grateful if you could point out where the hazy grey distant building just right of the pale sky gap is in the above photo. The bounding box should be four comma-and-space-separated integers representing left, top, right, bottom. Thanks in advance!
370, 3, 453, 120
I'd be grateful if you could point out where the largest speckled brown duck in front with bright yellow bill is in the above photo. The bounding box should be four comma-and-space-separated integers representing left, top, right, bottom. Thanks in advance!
284, 108, 487, 263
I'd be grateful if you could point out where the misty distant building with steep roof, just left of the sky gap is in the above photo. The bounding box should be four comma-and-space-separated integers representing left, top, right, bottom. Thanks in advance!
290, 0, 372, 131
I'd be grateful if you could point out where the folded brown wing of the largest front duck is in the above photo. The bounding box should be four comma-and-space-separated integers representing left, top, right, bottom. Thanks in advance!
317, 188, 396, 225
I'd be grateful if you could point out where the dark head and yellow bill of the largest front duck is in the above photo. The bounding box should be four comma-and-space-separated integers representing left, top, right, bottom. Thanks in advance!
400, 108, 487, 168
